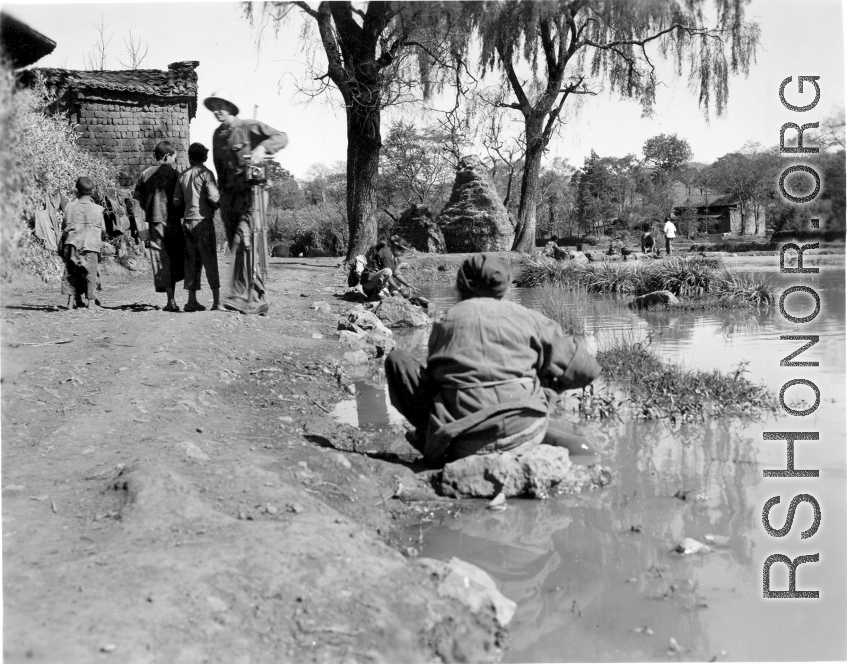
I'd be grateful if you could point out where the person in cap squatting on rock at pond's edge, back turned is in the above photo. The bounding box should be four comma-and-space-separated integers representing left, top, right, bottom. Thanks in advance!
385, 254, 600, 465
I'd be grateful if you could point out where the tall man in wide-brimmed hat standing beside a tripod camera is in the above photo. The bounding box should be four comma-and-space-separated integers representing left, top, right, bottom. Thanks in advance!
203, 90, 288, 314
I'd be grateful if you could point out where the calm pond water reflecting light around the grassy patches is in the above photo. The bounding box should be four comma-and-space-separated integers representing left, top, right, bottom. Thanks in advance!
337, 268, 847, 662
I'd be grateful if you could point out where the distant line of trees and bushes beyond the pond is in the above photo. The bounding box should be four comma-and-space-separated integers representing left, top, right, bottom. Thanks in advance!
269, 109, 845, 255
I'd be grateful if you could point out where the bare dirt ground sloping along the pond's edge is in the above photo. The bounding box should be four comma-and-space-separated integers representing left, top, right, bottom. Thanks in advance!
0, 258, 506, 663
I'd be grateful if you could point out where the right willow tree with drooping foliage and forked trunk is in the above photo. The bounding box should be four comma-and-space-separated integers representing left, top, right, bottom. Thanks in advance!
470, 0, 759, 251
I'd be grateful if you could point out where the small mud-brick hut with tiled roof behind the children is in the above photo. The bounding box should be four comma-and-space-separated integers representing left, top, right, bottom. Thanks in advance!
21, 61, 200, 180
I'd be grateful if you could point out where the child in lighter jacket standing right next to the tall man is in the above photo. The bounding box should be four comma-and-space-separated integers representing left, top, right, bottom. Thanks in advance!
174, 143, 221, 311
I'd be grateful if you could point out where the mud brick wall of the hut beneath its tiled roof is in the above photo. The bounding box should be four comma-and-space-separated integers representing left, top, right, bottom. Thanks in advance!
75, 99, 189, 178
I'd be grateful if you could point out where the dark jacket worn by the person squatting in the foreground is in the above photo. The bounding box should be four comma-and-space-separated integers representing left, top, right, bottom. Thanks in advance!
424, 297, 600, 458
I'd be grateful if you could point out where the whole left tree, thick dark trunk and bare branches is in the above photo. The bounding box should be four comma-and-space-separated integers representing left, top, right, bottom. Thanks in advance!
245, 0, 468, 256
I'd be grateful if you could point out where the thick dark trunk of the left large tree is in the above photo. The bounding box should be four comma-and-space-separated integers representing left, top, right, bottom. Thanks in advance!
347, 104, 382, 260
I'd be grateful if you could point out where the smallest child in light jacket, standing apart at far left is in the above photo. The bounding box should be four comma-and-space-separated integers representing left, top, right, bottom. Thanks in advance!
62, 177, 106, 310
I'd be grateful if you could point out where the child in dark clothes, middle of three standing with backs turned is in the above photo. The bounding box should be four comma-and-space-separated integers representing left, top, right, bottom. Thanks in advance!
134, 141, 185, 311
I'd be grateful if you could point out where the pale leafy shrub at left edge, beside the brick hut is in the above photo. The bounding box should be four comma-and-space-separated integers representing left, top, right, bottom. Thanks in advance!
0, 65, 117, 282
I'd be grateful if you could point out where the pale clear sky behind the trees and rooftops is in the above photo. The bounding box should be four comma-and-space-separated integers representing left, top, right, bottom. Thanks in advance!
3, 0, 845, 178
